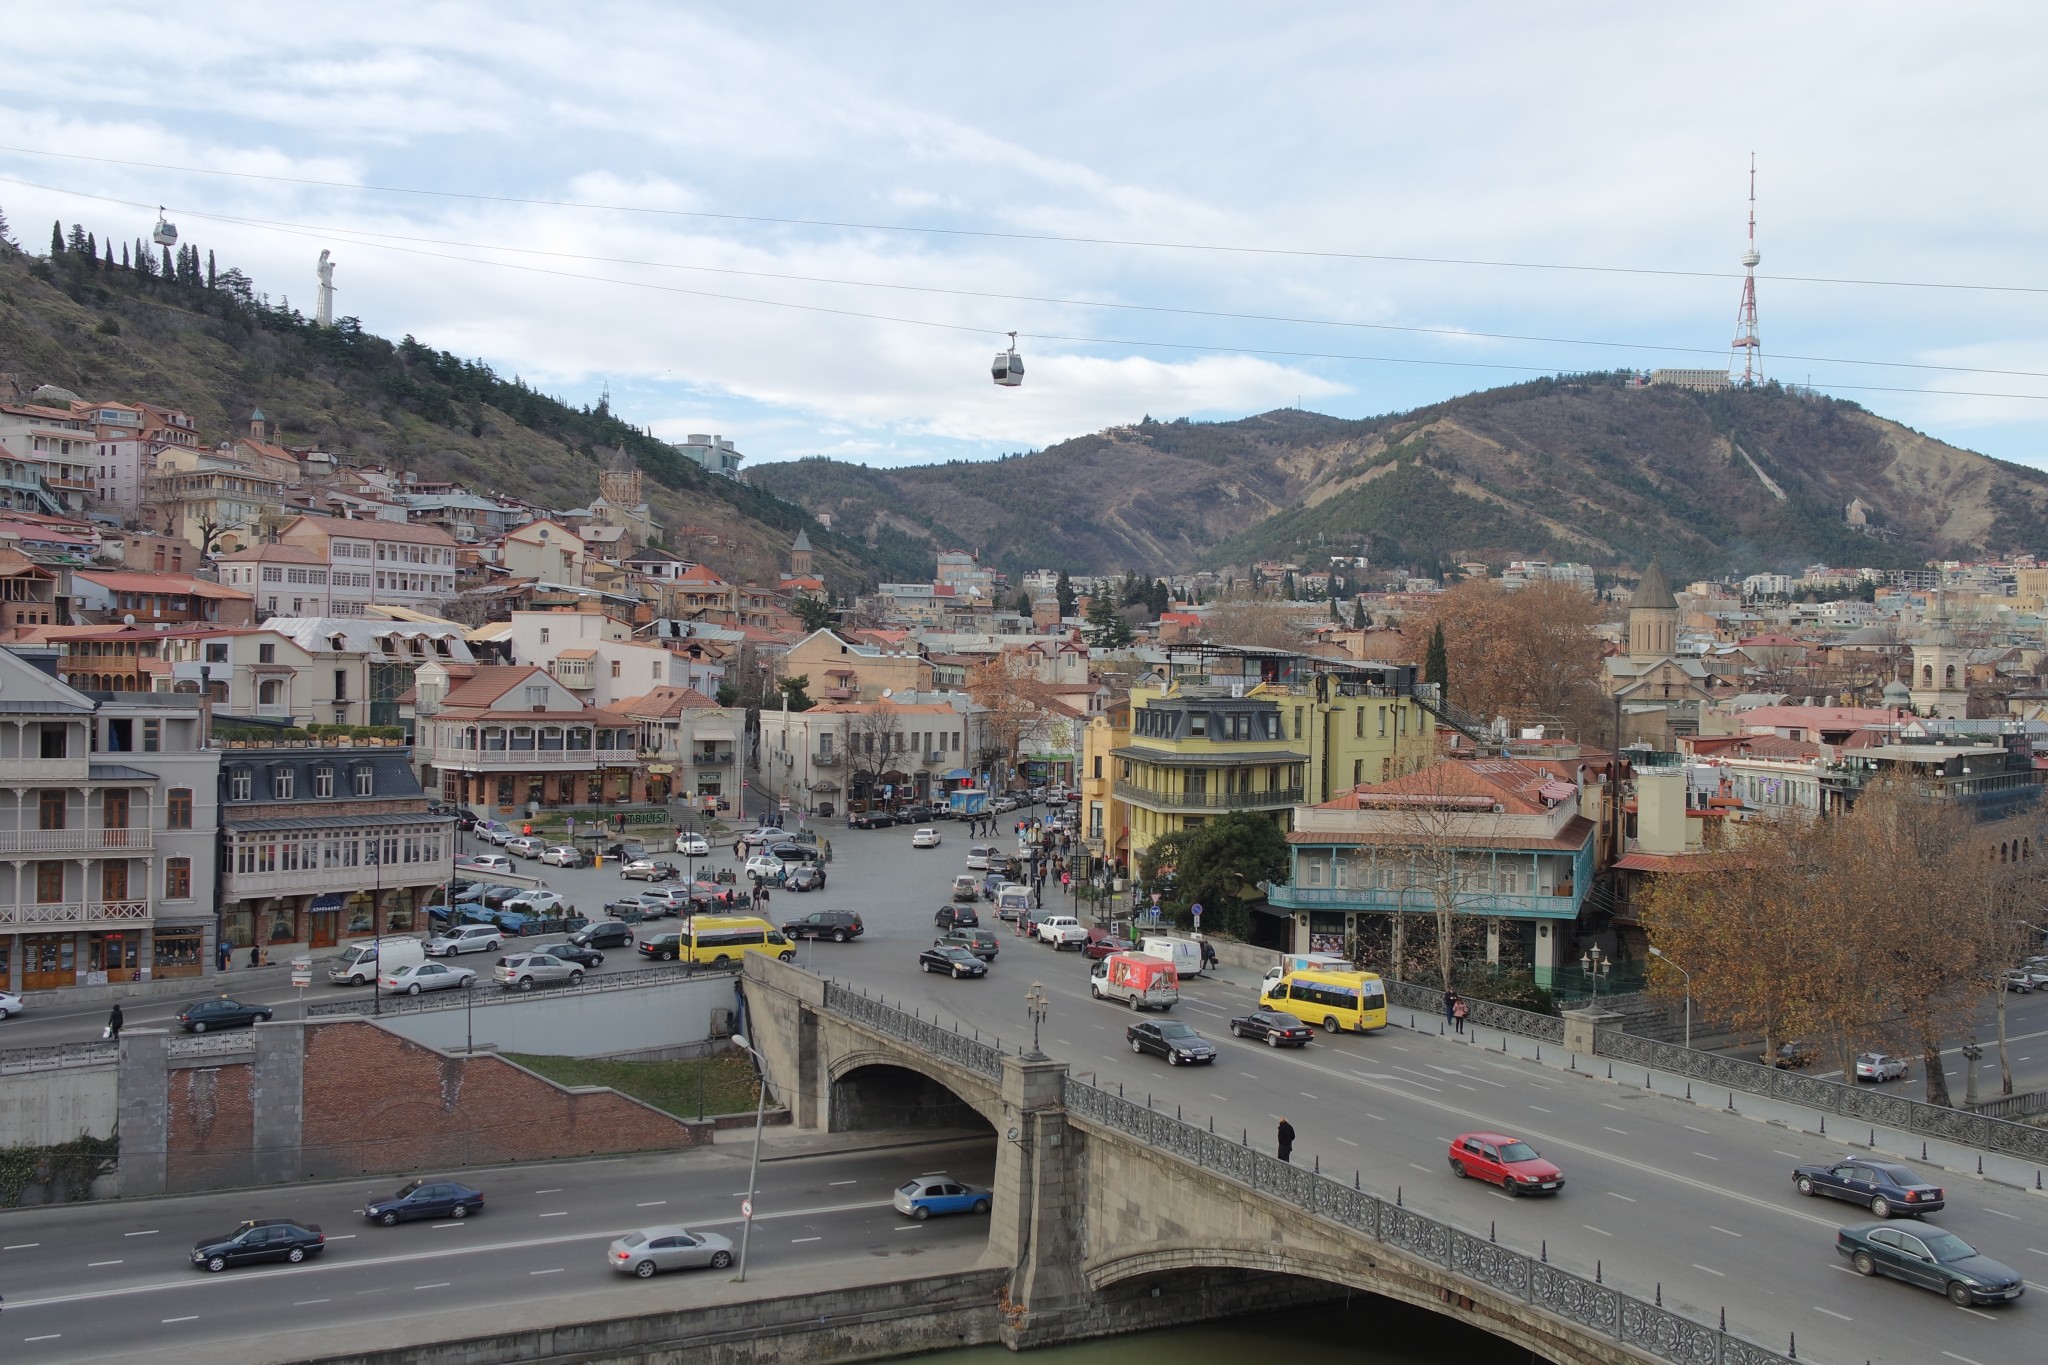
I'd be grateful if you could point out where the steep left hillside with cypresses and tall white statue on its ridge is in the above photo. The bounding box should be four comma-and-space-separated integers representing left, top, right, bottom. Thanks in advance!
0, 229, 932, 591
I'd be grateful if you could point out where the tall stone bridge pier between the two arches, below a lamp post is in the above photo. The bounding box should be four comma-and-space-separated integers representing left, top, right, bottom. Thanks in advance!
983, 1056, 1090, 1351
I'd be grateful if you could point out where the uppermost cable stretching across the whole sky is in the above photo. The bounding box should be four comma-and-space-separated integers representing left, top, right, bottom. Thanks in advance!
0, 143, 2048, 295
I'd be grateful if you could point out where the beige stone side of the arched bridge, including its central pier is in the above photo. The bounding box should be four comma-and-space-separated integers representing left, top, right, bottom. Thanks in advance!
745, 956, 1790, 1365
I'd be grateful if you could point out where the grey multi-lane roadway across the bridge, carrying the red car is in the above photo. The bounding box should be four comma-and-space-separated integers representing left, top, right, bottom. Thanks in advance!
786, 829, 2048, 1365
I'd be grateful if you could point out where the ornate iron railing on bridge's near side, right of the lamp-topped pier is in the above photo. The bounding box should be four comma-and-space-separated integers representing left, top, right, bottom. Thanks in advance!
1064, 1080, 1790, 1365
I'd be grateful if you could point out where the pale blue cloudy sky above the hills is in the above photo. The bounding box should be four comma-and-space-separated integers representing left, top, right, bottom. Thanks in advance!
0, 0, 2048, 467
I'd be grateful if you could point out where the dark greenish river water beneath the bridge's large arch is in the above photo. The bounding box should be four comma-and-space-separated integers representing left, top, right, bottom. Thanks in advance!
881, 1293, 1542, 1365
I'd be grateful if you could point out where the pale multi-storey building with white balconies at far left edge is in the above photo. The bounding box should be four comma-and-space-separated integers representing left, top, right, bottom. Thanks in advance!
0, 647, 219, 993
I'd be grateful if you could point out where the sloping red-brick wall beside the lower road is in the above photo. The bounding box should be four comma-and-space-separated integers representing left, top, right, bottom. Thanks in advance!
301, 1019, 709, 1179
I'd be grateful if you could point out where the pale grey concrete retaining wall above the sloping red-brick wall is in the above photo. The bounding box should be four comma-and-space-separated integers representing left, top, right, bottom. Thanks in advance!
381, 978, 741, 1056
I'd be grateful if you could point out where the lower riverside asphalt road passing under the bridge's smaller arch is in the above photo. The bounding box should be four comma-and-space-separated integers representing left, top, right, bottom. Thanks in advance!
0, 1142, 995, 1363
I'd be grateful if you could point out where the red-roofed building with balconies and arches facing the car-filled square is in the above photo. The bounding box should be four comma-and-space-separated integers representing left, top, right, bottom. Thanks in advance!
414, 663, 643, 817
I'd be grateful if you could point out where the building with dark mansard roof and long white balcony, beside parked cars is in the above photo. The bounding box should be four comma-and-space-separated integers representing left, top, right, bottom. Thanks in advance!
215, 712, 455, 960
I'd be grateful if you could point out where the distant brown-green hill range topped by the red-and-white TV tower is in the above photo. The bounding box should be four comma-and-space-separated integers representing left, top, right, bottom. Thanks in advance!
750, 375, 2048, 575
